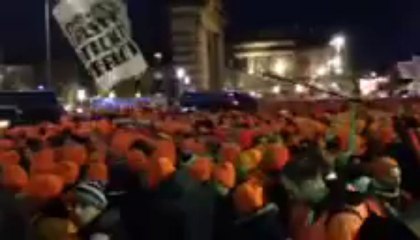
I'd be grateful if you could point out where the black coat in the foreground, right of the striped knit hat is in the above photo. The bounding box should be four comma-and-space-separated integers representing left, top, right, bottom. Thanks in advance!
121, 173, 185, 240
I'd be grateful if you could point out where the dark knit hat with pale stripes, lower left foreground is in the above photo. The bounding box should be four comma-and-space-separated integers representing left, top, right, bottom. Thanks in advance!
74, 181, 108, 209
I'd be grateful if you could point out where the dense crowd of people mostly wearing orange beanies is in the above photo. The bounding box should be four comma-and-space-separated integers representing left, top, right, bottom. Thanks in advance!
0, 104, 420, 240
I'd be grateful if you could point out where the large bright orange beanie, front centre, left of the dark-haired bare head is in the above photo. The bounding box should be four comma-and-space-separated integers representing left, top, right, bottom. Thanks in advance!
233, 180, 264, 214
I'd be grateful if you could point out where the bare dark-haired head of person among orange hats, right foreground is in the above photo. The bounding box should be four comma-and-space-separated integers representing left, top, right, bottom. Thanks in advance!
282, 154, 328, 204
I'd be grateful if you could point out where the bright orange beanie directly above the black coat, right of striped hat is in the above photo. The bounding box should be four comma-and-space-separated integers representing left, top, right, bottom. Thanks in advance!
147, 158, 176, 188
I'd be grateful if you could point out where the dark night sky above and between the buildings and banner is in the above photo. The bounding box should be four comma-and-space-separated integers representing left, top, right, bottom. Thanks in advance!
0, 0, 420, 69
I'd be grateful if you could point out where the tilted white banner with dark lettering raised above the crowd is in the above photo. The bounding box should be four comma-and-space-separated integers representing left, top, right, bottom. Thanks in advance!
53, 0, 147, 90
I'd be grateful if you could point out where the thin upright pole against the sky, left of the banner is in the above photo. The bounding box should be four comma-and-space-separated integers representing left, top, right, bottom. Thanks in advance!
44, 0, 52, 88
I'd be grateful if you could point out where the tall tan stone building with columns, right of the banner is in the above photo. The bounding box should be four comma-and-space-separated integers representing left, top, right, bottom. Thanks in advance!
171, 0, 225, 90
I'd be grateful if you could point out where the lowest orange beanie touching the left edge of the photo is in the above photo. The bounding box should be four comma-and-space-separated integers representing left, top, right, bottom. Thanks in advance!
2, 164, 28, 192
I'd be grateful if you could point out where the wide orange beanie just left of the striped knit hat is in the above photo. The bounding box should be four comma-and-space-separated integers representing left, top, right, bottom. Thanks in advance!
25, 174, 64, 200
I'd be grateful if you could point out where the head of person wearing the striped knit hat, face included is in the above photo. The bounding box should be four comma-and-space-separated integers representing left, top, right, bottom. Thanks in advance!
73, 182, 108, 226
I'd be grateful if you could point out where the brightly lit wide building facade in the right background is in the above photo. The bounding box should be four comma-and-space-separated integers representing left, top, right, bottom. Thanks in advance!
230, 31, 353, 97
